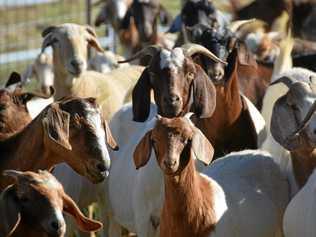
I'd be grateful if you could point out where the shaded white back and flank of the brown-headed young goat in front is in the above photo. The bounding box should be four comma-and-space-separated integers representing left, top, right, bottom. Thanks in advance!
203, 150, 289, 237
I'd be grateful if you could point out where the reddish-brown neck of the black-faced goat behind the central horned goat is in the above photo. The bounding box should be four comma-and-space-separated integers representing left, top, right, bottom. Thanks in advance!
196, 57, 257, 158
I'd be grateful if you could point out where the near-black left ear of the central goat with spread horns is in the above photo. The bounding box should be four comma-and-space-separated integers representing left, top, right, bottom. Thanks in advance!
132, 68, 151, 122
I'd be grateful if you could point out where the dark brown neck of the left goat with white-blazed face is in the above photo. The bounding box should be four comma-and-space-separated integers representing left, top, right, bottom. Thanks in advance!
0, 116, 57, 190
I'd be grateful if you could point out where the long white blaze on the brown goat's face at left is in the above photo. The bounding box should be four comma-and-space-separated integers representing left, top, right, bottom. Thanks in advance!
87, 105, 111, 172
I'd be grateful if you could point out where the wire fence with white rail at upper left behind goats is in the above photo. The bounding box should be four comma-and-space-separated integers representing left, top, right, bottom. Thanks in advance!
0, 0, 114, 84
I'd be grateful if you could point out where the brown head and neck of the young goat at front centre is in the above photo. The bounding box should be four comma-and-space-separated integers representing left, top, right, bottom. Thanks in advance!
134, 117, 216, 237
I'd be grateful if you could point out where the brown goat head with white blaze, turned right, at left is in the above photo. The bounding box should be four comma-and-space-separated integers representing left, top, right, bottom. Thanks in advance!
43, 98, 118, 183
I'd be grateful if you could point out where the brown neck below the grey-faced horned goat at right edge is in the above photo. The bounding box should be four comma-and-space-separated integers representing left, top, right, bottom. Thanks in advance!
291, 148, 316, 189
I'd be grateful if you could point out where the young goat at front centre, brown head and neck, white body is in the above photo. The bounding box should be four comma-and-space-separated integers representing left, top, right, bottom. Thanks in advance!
133, 116, 289, 237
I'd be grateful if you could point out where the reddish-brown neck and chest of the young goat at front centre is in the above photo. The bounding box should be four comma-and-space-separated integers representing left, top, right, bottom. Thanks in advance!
160, 152, 216, 237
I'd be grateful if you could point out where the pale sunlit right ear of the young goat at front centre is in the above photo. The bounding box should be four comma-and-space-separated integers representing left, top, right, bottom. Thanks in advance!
191, 128, 214, 165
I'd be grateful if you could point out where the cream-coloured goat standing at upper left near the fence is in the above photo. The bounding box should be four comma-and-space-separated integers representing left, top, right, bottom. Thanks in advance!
42, 24, 143, 119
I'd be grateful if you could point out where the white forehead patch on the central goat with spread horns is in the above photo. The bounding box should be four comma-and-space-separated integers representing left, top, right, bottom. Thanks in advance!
160, 48, 185, 72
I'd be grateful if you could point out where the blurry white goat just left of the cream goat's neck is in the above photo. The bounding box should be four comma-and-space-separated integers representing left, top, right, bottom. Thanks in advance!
22, 52, 54, 94
